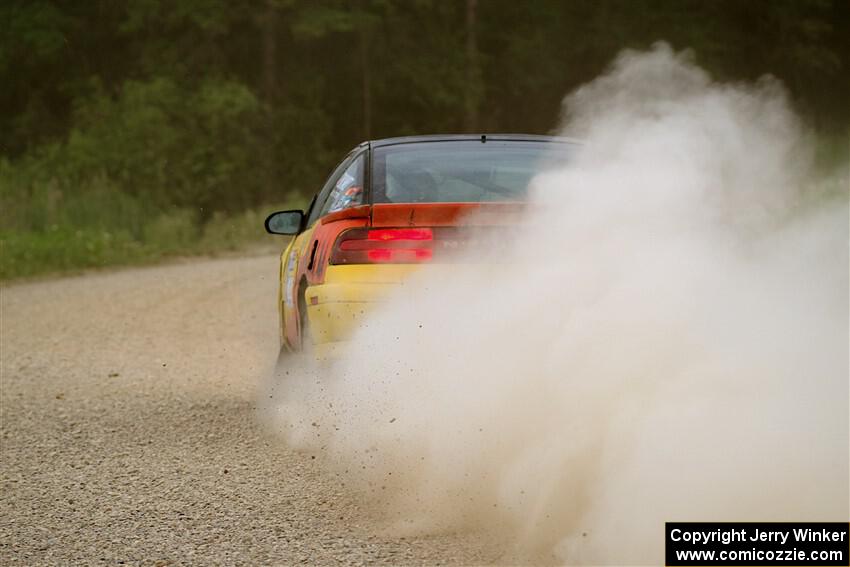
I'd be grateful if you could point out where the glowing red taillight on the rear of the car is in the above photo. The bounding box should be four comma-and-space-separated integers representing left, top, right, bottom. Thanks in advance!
330, 228, 434, 264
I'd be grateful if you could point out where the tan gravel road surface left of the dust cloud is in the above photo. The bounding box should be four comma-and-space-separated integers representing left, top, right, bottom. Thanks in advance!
0, 255, 499, 565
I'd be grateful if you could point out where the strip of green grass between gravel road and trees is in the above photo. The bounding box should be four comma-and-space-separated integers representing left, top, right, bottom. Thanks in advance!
0, 204, 298, 280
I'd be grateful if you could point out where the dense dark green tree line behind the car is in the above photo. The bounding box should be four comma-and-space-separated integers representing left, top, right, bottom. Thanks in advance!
0, 0, 850, 230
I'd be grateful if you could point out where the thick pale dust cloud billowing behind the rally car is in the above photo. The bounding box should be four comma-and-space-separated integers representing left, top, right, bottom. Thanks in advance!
276, 44, 850, 564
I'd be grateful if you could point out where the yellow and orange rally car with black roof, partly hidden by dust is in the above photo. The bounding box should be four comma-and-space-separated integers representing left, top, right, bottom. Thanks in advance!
265, 134, 575, 356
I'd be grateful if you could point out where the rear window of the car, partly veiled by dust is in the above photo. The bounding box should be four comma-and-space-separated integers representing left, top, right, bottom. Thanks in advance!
372, 140, 572, 203
